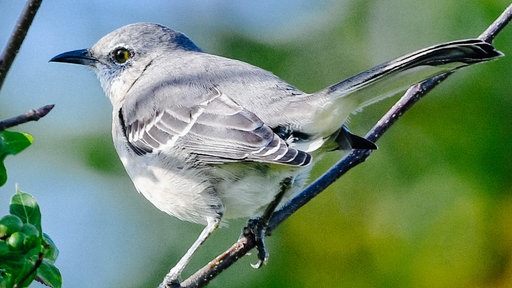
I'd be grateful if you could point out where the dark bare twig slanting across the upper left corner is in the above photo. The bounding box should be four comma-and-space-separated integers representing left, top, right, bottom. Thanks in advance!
0, 0, 42, 89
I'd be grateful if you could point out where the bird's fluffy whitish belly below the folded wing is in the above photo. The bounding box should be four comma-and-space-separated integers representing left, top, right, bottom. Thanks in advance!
116, 138, 313, 224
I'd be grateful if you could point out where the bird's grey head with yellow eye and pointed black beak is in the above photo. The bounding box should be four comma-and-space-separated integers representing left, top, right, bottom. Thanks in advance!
50, 23, 200, 103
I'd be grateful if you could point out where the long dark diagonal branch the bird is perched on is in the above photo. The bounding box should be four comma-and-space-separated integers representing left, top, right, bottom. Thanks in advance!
174, 4, 512, 287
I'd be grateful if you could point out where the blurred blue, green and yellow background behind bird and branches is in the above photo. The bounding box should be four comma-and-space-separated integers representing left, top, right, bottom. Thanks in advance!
0, 0, 512, 287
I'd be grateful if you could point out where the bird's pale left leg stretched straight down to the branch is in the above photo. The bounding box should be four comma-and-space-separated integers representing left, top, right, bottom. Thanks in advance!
160, 217, 220, 288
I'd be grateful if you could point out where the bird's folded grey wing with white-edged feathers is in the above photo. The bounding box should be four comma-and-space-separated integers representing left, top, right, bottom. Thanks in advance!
119, 88, 311, 166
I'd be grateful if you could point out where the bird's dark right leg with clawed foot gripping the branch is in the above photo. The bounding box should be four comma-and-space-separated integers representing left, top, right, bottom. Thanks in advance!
242, 177, 293, 269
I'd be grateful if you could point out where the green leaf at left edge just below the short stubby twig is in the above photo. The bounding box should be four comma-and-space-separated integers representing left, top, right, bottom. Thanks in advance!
0, 131, 34, 186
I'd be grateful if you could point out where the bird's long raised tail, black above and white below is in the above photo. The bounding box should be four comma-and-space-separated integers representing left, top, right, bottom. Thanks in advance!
304, 39, 503, 140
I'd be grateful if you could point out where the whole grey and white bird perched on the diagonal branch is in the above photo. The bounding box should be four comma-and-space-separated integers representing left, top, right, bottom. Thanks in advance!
50, 23, 503, 285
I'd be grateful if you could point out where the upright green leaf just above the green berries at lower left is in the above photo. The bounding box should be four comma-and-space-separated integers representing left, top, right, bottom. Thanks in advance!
9, 189, 43, 235
